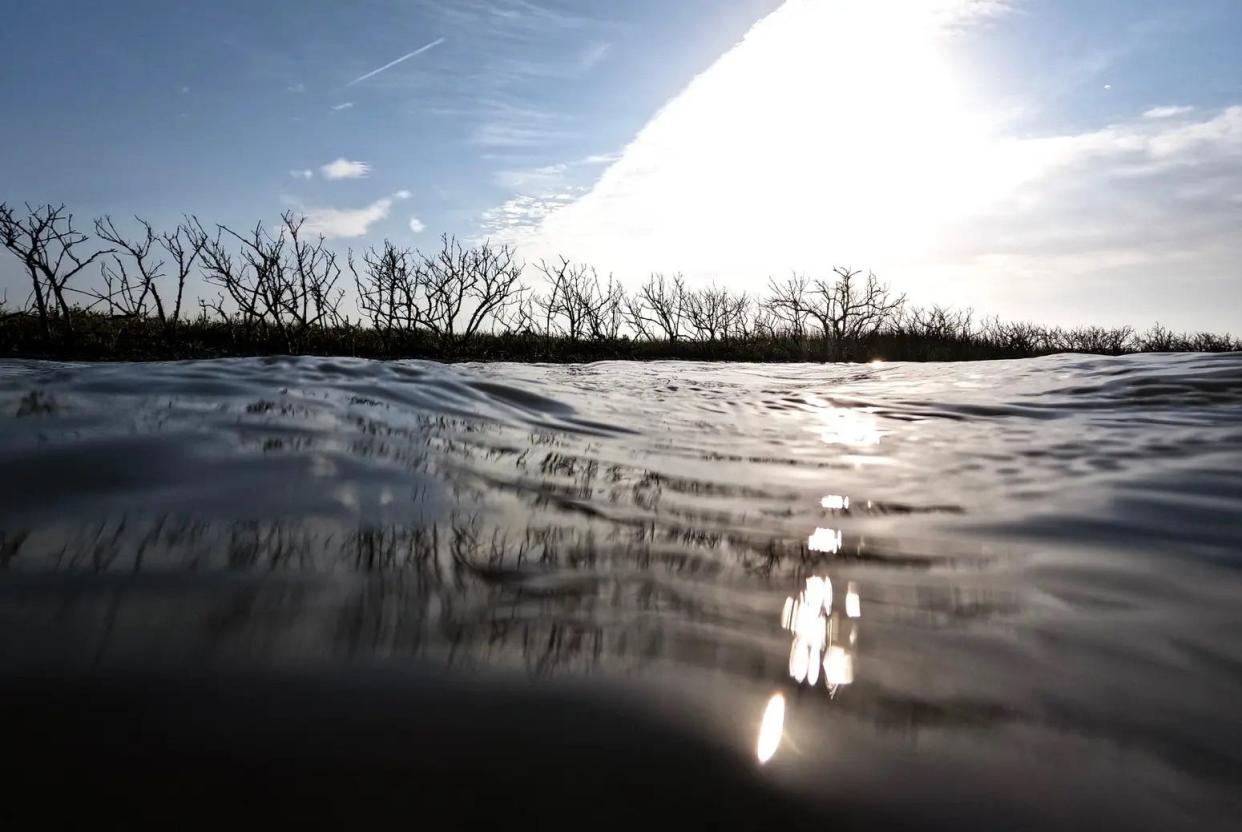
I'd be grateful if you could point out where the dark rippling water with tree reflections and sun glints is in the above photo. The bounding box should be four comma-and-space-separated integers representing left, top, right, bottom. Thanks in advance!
0, 354, 1242, 828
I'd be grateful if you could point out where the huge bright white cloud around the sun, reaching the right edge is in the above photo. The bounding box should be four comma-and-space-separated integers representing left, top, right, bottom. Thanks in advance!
483, 0, 1242, 328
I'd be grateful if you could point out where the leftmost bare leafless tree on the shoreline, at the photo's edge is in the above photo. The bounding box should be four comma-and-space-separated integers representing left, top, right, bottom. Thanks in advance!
0, 202, 112, 337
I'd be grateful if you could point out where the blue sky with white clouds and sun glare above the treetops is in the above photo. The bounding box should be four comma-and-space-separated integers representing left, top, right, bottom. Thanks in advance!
0, 0, 1242, 333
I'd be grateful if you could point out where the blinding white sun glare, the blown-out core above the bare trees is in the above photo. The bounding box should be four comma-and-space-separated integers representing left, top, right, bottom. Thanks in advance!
524, 0, 1013, 288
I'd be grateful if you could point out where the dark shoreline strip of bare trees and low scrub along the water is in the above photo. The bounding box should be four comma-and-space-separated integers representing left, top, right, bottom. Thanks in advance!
0, 204, 1242, 361
